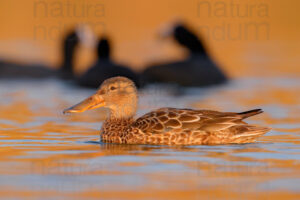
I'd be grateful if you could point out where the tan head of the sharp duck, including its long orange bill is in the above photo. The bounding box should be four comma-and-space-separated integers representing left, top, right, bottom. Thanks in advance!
63, 77, 138, 119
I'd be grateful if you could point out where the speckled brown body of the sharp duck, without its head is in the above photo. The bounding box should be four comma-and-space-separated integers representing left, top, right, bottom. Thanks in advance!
101, 108, 269, 145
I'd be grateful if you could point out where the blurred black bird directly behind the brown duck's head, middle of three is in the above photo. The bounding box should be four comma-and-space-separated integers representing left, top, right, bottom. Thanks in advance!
77, 37, 140, 88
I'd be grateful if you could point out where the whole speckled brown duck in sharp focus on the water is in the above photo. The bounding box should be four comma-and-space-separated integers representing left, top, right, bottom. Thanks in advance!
63, 77, 270, 145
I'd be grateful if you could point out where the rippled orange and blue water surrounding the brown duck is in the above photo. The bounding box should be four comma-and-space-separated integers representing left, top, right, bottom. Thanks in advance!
0, 78, 300, 199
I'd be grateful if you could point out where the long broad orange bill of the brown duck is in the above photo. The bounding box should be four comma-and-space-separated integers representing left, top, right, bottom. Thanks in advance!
63, 94, 105, 114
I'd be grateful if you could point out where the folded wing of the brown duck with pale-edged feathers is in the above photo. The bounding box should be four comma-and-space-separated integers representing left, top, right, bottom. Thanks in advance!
134, 108, 262, 133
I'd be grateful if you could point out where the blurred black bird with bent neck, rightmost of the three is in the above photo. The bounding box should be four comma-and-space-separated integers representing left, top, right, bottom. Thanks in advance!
141, 23, 228, 87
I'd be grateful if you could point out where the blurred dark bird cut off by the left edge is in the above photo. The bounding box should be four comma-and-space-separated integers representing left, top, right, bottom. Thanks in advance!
0, 30, 79, 79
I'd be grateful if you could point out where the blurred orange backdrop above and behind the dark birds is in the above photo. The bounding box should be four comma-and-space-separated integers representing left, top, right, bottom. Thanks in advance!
0, 0, 300, 77
